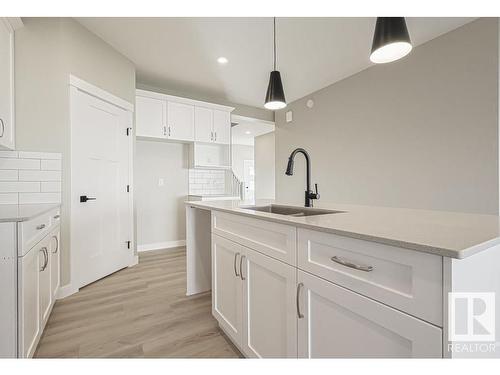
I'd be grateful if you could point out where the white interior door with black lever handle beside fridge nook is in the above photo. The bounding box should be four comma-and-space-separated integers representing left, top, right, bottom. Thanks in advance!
71, 87, 133, 287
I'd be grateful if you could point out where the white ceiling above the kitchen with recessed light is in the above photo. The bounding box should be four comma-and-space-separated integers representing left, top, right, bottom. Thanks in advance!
77, 18, 474, 107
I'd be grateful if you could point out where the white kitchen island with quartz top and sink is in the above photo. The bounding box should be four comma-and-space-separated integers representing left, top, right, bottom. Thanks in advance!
186, 201, 500, 357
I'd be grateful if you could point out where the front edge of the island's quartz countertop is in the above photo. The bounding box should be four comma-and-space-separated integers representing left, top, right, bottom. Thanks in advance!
185, 201, 500, 259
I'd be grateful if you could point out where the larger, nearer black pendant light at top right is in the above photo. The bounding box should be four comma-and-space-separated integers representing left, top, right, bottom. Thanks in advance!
370, 17, 412, 64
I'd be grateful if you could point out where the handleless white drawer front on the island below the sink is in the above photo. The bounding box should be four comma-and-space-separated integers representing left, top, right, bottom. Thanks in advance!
212, 212, 297, 266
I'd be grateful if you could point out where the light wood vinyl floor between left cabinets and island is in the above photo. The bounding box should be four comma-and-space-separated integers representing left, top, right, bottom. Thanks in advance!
35, 248, 241, 358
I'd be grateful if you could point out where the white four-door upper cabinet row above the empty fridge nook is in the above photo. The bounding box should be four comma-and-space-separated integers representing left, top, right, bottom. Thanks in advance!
136, 90, 233, 144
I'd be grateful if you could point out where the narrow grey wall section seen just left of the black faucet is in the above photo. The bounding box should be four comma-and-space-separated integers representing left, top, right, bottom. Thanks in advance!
254, 132, 280, 199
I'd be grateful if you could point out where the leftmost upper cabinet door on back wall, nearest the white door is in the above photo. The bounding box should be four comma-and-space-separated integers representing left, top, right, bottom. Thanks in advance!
135, 96, 166, 138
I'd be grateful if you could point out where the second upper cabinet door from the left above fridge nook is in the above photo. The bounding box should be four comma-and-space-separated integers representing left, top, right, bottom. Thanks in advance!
167, 102, 194, 141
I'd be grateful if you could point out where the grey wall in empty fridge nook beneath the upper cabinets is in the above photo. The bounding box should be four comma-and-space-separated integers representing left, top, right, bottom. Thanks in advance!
134, 141, 189, 249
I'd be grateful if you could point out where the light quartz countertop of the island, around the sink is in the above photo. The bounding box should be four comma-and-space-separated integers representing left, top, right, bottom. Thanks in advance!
186, 200, 500, 259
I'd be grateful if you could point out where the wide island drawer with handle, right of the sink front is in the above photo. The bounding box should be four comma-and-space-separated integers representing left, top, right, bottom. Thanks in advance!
297, 228, 442, 326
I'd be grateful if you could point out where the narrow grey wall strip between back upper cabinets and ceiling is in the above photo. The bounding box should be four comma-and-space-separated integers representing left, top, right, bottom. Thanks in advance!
137, 82, 274, 121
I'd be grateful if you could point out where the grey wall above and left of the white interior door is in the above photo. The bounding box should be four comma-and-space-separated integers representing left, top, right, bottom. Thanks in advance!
15, 18, 135, 285
